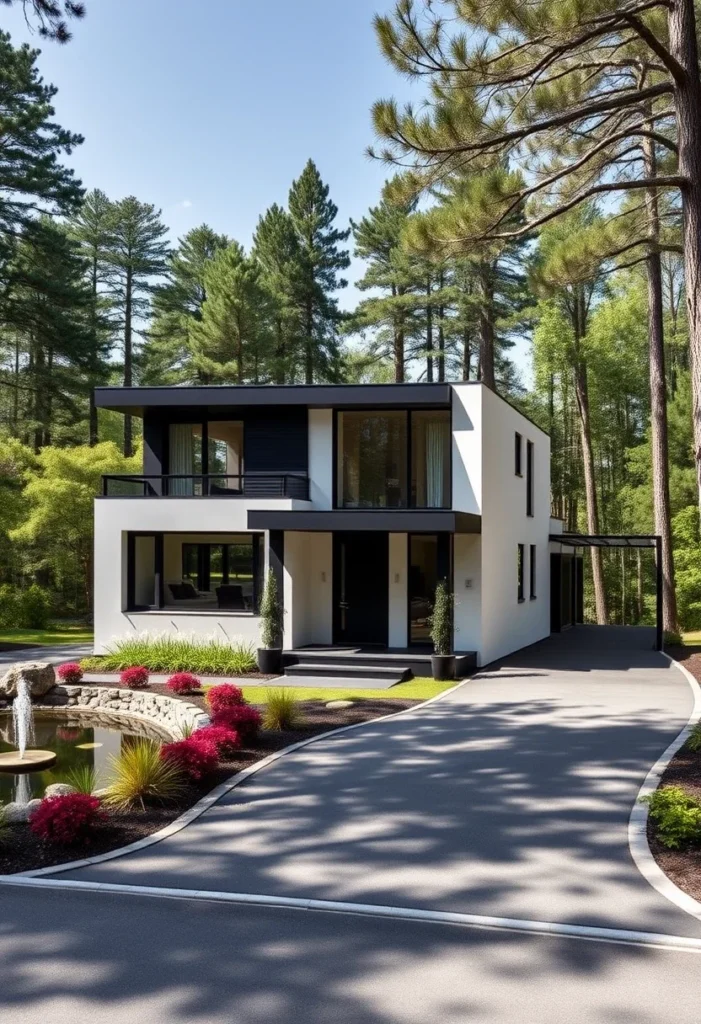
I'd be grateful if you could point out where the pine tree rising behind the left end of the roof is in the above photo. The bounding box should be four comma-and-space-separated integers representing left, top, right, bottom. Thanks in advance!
147, 224, 229, 384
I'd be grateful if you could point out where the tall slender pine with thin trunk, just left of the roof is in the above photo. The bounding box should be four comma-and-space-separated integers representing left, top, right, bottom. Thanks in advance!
69, 188, 113, 444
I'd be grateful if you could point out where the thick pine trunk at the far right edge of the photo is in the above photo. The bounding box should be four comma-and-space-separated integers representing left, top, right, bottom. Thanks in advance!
668, 0, 701, 524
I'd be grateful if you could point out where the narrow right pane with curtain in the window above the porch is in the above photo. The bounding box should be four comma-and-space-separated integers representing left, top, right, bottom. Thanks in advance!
411, 410, 450, 509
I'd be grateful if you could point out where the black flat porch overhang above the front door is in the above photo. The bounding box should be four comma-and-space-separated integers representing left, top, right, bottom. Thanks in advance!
249, 509, 482, 534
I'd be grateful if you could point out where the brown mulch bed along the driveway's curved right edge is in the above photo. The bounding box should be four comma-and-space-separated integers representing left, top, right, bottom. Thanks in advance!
648, 646, 701, 900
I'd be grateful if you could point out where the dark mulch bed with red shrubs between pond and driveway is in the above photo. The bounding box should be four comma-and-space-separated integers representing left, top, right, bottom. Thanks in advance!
0, 696, 421, 874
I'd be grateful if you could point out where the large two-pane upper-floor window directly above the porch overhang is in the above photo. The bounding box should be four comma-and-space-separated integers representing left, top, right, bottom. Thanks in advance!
337, 410, 450, 508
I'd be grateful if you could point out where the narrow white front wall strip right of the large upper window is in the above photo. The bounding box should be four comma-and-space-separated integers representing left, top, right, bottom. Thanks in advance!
452, 384, 485, 515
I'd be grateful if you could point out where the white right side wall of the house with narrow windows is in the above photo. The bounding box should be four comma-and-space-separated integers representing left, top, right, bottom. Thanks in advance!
479, 388, 551, 665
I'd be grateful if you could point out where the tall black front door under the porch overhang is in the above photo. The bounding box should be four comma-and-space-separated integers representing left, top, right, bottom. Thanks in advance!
334, 532, 389, 644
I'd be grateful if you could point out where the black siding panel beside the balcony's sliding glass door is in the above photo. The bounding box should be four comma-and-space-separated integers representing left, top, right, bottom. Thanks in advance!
244, 407, 309, 474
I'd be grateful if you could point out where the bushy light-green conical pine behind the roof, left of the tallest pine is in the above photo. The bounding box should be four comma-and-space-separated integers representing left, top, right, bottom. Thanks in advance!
192, 242, 268, 384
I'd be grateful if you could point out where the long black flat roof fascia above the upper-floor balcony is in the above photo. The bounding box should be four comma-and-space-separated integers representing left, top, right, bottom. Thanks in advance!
95, 384, 451, 416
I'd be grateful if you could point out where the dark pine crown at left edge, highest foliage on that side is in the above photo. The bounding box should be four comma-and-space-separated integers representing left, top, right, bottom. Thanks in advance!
0, 32, 83, 261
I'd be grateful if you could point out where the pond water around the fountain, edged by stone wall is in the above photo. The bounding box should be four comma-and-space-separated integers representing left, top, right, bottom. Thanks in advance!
0, 713, 163, 804
